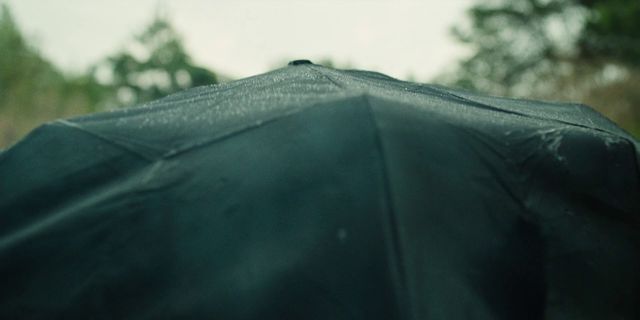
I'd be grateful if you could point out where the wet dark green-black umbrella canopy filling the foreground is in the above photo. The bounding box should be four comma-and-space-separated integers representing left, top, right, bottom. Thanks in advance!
0, 61, 640, 319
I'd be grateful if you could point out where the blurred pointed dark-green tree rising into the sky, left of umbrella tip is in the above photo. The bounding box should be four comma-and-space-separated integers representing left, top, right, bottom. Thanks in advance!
93, 15, 218, 106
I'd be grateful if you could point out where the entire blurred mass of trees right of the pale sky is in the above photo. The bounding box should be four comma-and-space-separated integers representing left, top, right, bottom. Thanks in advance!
436, 0, 640, 135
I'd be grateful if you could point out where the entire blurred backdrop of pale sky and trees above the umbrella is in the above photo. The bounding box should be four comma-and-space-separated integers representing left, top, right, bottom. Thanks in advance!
0, 0, 640, 149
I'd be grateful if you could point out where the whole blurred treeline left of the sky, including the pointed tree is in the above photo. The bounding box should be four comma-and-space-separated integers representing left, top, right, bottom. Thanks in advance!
0, 5, 219, 149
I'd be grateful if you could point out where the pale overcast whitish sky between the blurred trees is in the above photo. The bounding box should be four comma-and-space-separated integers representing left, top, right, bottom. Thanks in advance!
5, 0, 472, 81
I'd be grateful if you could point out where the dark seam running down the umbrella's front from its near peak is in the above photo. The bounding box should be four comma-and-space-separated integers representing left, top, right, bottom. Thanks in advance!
362, 94, 414, 319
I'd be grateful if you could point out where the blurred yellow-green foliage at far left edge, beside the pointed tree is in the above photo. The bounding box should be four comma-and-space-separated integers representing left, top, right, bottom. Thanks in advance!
0, 5, 106, 148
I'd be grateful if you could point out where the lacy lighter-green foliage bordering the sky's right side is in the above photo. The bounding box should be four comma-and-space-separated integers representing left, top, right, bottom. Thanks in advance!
444, 0, 579, 95
